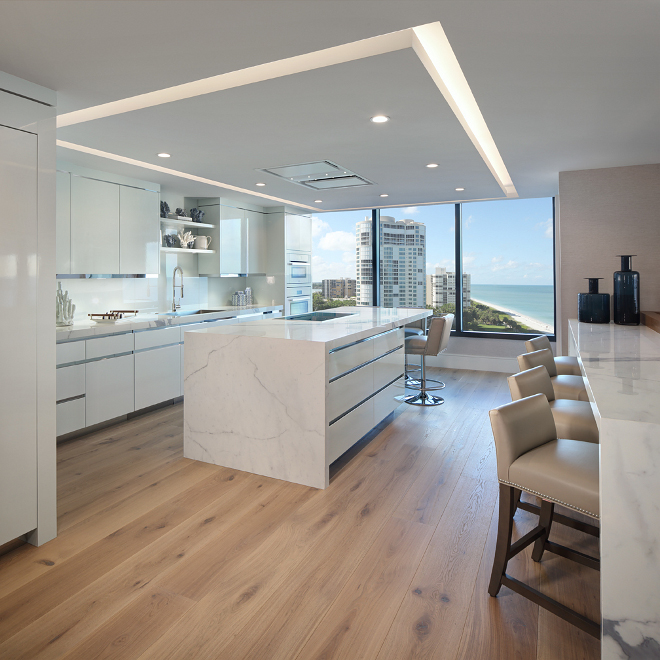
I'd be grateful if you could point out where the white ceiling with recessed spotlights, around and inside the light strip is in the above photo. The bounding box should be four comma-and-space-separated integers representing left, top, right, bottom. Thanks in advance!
0, 0, 660, 208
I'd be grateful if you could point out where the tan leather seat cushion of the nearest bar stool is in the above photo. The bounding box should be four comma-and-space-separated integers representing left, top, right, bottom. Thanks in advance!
509, 438, 600, 518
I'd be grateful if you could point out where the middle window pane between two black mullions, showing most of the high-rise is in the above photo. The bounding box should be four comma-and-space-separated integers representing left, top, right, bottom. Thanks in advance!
380, 204, 456, 328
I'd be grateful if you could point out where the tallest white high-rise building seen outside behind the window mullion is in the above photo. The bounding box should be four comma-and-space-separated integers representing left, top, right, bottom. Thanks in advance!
356, 215, 426, 307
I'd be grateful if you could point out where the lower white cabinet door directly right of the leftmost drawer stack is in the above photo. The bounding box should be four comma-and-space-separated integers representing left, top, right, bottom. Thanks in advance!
85, 355, 135, 426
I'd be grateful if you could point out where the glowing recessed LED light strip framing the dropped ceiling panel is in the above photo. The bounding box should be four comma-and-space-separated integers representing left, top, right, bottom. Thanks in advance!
57, 22, 518, 204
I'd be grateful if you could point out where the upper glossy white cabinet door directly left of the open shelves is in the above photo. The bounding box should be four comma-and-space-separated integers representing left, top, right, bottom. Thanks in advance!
119, 186, 160, 275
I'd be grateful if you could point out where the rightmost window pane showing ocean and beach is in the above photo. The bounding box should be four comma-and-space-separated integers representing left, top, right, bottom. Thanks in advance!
462, 198, 555, 334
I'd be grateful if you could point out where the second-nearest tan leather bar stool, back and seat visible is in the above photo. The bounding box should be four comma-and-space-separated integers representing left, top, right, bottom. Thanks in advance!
507, 366, 599, 443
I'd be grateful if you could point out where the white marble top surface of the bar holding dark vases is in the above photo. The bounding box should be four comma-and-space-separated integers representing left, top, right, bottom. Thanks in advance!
569, 320, 660, 424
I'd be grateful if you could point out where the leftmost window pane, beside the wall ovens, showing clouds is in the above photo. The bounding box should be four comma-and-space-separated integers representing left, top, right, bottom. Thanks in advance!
312, 211, 371, 310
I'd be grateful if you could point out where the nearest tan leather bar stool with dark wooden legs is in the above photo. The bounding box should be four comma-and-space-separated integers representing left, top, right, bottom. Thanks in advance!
488, 394, 600, 639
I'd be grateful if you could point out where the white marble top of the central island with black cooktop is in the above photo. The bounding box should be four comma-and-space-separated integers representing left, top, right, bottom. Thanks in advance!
186, 307, 432, 350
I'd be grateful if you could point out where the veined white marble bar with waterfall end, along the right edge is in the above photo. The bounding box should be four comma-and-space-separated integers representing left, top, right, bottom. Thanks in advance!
569, 321, 660, 660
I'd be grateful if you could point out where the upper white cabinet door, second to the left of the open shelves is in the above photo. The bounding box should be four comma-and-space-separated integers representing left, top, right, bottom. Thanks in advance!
71, 175, 119, 274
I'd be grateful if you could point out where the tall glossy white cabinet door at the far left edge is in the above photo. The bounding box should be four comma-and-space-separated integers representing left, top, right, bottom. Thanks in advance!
0, 126, 37, 545
